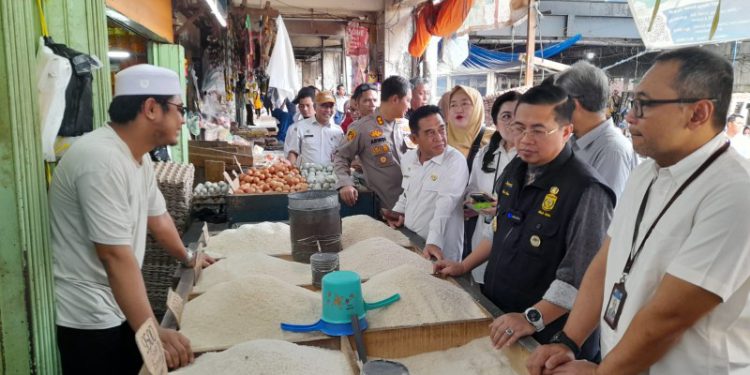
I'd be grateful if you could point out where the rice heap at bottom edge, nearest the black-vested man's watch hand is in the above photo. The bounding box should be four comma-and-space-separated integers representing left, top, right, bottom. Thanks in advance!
396, 336, 516, 375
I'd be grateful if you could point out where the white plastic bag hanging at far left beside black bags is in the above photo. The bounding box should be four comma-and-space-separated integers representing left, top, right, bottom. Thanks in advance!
36, 38, 73, 162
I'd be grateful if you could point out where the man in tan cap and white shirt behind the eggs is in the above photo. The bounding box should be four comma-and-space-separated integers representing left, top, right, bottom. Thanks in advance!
287, 91, 344, 166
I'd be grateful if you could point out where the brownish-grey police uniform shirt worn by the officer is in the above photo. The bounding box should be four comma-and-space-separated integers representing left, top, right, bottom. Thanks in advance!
333, 110, 414, 209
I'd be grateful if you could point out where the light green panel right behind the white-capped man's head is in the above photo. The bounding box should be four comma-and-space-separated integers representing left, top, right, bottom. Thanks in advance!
148, 43, 190, 163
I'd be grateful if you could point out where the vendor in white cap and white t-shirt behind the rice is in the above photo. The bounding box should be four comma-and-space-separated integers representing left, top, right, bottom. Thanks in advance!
49, 65, 213, 374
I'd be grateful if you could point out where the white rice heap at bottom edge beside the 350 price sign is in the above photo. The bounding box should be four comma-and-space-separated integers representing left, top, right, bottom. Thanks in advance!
170, 340, 354, 375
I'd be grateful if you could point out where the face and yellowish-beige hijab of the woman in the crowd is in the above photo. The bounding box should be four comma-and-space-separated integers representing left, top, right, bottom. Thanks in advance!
447, 85, 492, 172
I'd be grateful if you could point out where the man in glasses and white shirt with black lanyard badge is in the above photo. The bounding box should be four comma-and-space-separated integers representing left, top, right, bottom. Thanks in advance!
527, 47, 750, 375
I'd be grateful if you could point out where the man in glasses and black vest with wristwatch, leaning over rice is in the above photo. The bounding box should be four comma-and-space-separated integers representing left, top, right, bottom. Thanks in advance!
435, 85, 615, 359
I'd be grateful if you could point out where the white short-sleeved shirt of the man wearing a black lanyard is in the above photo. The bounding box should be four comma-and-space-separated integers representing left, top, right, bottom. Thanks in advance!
601, 134, 750, 375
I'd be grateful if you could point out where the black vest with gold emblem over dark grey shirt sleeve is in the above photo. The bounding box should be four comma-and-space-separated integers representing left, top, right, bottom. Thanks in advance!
483, 144, 615, 359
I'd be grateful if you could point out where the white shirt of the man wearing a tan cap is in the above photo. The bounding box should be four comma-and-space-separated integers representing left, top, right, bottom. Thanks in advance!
285, 116, 344, 166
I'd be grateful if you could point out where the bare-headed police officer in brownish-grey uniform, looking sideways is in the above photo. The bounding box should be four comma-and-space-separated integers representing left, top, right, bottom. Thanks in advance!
333, 76, 413, 209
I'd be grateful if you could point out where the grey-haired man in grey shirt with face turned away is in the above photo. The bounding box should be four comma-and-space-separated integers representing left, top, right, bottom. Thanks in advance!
555, 61, 638, 197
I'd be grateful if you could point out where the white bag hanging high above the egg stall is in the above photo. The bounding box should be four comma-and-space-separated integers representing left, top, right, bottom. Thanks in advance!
267, 15, 300, 107
